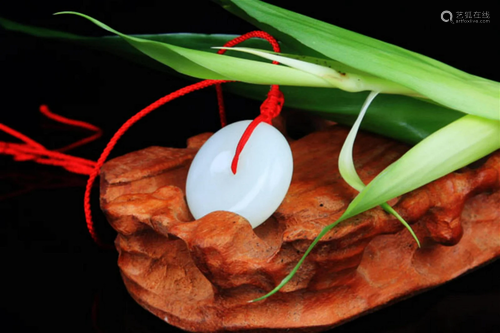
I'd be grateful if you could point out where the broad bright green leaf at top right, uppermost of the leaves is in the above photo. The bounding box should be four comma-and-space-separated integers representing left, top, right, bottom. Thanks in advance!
217, 0, 500, 120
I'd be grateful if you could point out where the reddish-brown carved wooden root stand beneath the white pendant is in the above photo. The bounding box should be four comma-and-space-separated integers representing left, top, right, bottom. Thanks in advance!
101, 122, 500, 332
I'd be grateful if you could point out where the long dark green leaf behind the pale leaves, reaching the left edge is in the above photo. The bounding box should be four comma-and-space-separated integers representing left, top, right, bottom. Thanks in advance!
0, 18, 463, 144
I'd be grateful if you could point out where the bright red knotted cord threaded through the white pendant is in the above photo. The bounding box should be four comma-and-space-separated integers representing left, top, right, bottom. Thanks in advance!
0, 31, 284, 247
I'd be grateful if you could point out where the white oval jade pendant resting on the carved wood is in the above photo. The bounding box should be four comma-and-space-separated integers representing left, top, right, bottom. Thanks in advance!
186, 120, 293, 228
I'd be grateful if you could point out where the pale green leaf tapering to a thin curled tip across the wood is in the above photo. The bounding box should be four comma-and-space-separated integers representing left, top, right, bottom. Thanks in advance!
252, 115, 500, 302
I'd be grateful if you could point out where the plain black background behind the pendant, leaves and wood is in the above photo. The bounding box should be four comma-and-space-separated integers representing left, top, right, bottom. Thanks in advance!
0, 1, 500, 333
